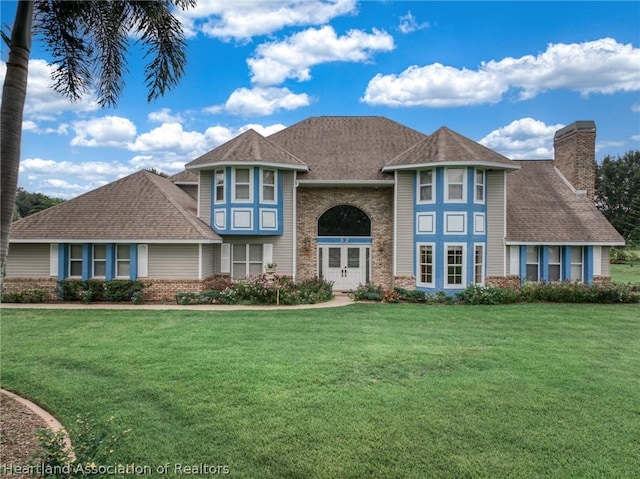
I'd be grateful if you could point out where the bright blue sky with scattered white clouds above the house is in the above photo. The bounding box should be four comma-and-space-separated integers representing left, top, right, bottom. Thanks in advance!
0, 0, 640, 198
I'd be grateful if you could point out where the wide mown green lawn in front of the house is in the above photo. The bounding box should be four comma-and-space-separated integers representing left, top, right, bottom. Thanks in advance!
1, 304, 640, 479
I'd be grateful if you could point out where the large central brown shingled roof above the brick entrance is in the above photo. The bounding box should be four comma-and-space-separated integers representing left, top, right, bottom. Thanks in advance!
269, 116, 426, 183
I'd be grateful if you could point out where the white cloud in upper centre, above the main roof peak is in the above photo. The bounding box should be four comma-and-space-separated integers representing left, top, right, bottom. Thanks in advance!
247, 26, 395, 86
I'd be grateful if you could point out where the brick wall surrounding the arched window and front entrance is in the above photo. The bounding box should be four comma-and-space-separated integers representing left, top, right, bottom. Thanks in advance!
296, 187, 393, 288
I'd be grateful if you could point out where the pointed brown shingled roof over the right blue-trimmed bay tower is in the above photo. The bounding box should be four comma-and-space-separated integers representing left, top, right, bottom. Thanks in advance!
383, 126, 518, 171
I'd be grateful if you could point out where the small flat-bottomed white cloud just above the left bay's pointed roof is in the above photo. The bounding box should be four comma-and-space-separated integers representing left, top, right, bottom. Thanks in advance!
214, 87, 311, 117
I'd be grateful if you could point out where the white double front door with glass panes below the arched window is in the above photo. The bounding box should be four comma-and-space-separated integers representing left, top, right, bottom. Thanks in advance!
319, 244, 371, 291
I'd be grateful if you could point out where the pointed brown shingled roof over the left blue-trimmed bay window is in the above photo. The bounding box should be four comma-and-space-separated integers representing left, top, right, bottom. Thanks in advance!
185, 130, 308, 171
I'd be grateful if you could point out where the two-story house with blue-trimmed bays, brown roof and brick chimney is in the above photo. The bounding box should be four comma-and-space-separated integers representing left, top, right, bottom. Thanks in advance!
7, 117, 624, 299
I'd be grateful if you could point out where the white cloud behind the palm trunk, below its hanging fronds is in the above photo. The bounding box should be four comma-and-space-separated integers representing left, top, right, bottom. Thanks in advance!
0, 59, 99, 120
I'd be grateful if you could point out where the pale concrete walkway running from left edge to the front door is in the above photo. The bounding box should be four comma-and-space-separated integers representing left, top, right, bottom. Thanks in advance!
0, 294, 353, 311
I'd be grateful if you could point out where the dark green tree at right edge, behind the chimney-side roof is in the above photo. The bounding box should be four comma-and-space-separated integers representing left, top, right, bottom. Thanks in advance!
596, 150, 640, 243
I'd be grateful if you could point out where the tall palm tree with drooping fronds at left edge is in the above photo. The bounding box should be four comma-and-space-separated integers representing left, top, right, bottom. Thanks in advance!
0, 0, 196, 293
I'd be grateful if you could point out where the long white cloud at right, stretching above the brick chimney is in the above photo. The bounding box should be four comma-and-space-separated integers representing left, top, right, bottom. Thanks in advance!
362, 38, 640, 107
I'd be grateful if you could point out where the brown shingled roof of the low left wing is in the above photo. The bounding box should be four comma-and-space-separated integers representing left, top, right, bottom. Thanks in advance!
11, 170, 222, 243
